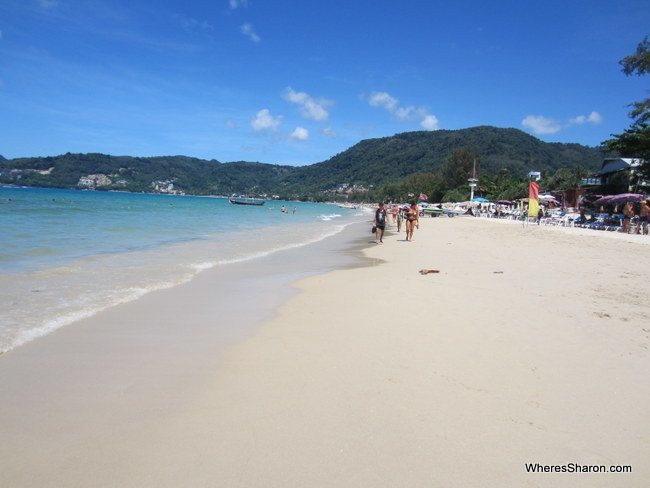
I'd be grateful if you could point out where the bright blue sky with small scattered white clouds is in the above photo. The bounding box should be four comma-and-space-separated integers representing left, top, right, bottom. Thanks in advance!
0, 0, 650, 164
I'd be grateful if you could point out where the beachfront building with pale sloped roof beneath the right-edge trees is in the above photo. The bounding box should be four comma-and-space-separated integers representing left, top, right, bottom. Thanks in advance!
581, 158, 650, 194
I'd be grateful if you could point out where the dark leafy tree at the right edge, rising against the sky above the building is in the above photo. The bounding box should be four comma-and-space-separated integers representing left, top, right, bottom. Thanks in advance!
603, 36, 650, 179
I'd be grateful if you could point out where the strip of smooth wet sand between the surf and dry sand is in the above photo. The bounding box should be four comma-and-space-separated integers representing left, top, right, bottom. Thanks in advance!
0, 223, 372, 487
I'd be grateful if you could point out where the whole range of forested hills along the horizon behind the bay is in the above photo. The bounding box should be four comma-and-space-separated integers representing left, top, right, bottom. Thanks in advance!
0, 126, 603, 198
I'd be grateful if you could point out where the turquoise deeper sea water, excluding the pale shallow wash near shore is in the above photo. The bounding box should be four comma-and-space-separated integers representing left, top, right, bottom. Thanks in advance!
0, 188, 352, 272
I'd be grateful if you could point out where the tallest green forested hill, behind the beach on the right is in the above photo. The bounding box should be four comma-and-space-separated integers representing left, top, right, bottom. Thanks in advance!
289, 126, 603, 191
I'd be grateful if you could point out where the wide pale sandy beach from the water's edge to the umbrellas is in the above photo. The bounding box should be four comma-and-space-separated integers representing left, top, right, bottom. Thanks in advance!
0, 217, 650, 487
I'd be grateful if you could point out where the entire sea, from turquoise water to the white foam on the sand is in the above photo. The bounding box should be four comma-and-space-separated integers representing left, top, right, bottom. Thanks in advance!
0, 187, 368, 353
